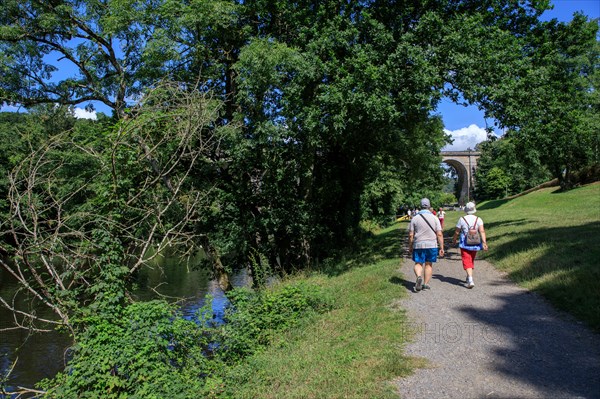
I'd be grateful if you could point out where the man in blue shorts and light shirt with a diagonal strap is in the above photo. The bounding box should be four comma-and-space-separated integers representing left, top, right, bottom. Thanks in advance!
408, 198, 444, 292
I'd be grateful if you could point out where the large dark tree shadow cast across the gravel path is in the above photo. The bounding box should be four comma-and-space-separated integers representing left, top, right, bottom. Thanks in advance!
458, 292, 600, 398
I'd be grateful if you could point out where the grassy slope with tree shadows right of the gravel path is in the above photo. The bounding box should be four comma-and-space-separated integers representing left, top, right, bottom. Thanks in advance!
446, 183, 600, 331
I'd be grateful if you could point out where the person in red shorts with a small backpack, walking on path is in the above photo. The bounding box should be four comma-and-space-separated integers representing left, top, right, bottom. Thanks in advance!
452, 202, 488, 288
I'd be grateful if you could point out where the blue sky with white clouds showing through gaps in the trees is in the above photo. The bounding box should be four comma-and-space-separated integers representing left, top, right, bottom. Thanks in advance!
0, 0, 600, 147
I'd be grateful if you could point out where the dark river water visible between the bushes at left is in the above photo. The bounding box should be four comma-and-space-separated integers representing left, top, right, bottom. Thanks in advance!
0, 258, 249, 390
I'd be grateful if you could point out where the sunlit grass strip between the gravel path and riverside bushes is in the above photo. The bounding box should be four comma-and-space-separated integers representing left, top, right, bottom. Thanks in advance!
220, 225, 422, 399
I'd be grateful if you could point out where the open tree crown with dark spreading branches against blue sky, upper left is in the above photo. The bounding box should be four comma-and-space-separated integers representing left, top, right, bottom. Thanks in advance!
0, 0, 176, 117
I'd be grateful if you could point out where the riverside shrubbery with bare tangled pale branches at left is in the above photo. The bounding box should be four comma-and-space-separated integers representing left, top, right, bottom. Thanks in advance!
0, 85, 229, 329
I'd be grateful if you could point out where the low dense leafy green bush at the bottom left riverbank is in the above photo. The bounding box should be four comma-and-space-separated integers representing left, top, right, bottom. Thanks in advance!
41, 301, 209, 399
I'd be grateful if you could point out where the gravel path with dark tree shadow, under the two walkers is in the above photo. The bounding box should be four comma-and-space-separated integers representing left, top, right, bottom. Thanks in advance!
396, 241, 600, 399
